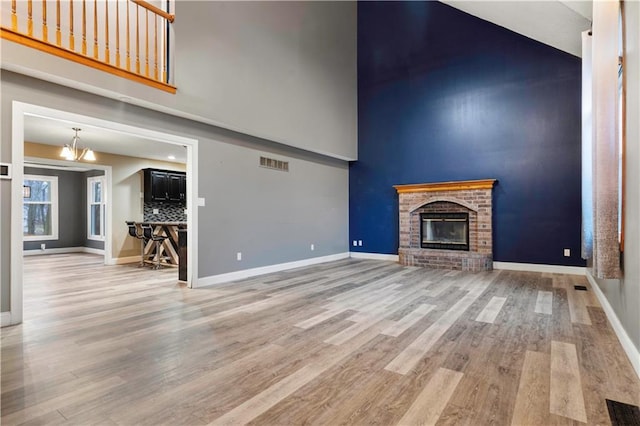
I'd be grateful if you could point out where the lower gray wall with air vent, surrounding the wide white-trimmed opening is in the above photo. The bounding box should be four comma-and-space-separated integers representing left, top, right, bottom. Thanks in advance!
0, 72, 349, 310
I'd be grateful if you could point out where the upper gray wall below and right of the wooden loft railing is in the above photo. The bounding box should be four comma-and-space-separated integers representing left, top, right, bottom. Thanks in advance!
0, 0, 357, 159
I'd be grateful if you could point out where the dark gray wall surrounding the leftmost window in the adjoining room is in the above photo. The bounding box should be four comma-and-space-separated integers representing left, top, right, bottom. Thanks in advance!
23, 167, 87, 250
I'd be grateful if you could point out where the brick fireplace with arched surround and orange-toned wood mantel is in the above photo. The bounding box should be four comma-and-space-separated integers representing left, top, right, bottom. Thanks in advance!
394, 179, 496, 271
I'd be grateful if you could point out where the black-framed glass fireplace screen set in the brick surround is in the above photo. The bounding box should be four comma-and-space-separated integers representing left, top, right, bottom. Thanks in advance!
420, 213, 469, 251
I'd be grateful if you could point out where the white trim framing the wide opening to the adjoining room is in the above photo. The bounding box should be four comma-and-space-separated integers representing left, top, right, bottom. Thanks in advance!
10, 101, 198, 324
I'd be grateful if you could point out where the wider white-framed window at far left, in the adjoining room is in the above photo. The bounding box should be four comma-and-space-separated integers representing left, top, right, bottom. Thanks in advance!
22, 175, 58, 241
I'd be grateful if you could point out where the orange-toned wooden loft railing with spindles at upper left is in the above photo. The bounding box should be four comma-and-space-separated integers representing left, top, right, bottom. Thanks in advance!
1, 0, 176, 93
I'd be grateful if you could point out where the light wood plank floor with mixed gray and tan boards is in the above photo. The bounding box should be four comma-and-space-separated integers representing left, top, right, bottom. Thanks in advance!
1, 254, 640, 425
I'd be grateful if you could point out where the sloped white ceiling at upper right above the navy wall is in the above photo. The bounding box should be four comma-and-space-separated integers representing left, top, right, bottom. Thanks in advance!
441, 0, 592, 57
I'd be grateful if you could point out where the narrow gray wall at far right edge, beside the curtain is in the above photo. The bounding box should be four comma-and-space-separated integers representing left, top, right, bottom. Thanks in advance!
597, 2, 640, 351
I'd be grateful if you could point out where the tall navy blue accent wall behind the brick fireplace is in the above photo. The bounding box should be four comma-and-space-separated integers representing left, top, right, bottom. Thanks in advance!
349, 2, 584, 266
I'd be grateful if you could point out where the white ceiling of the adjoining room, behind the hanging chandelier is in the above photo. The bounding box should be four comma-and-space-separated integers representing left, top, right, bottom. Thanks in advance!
24, 115, 187, 163
